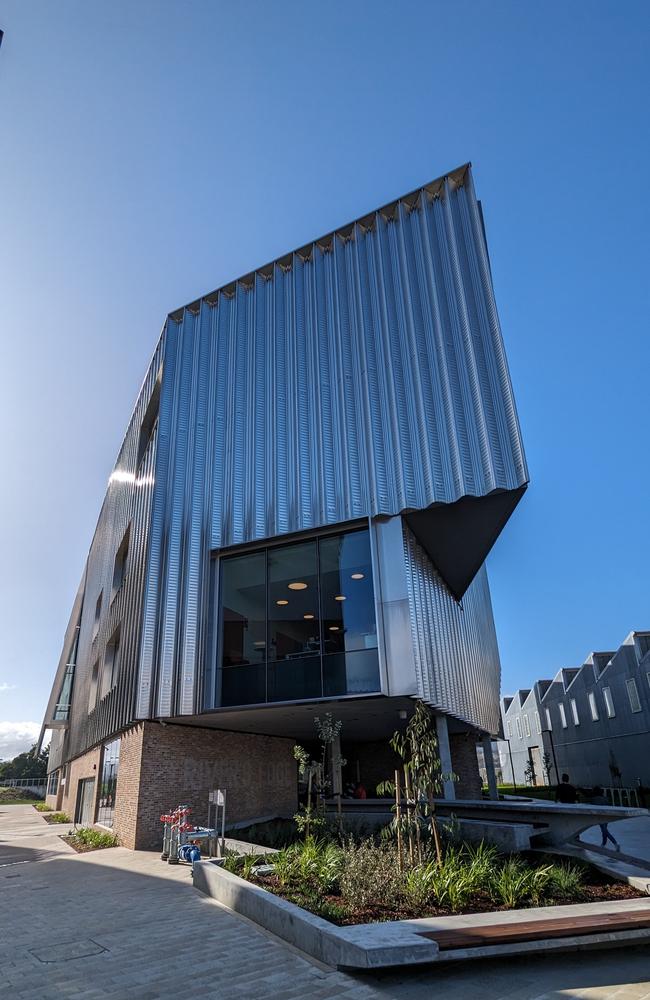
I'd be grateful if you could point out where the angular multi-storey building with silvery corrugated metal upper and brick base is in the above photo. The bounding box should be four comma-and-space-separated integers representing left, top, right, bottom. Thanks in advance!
39, 166, 527, 846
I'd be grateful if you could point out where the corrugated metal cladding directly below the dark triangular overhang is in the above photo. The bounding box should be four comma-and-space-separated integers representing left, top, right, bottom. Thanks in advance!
403, 525, 501, 734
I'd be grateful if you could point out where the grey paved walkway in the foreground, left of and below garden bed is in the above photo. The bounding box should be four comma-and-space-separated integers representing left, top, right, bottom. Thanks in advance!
0, 806, 650, 1000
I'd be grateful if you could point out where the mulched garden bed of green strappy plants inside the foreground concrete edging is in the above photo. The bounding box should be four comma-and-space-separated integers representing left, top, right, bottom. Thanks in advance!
226, 840, 643, 927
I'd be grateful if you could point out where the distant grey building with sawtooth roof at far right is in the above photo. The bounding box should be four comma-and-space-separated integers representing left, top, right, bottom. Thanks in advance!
499, 631, 650, 789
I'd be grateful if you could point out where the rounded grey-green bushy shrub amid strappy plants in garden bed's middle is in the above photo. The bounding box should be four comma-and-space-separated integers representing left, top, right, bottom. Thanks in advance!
339, 840, 403, 909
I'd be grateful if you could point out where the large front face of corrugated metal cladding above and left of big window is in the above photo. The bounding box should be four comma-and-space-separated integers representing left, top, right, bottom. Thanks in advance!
138, 168, 527, 716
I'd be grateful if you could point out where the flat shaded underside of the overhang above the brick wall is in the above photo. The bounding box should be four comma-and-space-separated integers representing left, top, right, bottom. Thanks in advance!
163, 695, 471, 742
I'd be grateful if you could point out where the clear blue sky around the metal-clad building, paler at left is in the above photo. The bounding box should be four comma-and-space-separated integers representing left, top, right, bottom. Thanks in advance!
0, 0, 650, 757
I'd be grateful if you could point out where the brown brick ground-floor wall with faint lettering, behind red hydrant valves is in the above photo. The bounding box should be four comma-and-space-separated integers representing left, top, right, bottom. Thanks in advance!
126, 722, 297, 850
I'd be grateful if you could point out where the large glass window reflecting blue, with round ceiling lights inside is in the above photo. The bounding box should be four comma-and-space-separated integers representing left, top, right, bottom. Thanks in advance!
216, 530, 379, 705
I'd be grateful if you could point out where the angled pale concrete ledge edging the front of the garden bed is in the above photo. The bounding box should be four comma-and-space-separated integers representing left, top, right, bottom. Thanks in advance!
194, 861, 650, 969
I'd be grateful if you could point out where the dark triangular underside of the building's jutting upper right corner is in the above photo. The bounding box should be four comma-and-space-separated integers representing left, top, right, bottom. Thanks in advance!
404, 486, 526, 601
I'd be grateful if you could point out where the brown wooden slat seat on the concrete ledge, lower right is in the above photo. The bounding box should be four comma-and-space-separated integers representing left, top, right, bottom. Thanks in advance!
419, 910, 650, 951
